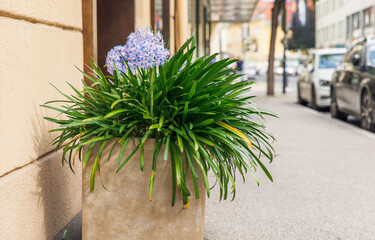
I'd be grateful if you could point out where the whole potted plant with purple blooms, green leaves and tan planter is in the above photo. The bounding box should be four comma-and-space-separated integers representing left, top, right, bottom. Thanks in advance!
42, 28, 274, 239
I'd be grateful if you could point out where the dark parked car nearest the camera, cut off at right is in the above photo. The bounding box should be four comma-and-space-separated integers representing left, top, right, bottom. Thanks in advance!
331, 38, 375, 131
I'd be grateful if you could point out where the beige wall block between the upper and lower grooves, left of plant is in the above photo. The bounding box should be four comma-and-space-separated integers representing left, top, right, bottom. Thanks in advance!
0, 17, 83, 175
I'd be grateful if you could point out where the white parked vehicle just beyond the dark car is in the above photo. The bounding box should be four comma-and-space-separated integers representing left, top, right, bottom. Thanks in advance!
297, 48, 346, 109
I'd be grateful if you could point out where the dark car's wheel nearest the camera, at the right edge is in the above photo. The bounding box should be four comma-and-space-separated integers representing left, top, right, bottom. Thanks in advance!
361, 91, 375, 131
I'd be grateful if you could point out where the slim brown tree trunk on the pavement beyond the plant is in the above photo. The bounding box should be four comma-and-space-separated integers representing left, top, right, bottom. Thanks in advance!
267, 0, 285, 96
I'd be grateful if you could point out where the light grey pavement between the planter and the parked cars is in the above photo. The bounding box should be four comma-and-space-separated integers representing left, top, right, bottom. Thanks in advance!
205, 78, 375, 240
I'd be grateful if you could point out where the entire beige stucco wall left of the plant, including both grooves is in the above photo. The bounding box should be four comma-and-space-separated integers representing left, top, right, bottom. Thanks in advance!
0, 0, 83, 240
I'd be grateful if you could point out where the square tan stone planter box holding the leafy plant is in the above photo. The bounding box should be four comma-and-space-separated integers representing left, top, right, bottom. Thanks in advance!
82, 140, 205, 240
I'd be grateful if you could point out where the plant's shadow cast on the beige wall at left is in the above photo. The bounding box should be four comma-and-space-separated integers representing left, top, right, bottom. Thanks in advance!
31, 109, 81, 239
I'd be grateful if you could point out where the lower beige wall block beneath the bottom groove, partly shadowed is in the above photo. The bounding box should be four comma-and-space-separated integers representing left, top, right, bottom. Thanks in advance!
0, 151, 82, 240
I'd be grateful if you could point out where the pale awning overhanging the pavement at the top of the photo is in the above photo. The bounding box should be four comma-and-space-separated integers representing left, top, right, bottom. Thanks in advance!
205, 0, 259, 22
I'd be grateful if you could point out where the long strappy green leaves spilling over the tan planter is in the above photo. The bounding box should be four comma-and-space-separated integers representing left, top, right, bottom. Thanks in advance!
42, 38, 274, 205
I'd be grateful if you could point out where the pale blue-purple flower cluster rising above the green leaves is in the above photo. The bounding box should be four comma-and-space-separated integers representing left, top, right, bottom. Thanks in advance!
106, 27, 169, 75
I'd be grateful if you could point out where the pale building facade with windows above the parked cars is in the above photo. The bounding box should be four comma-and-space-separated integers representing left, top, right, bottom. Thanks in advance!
315, 0, 375, 48
